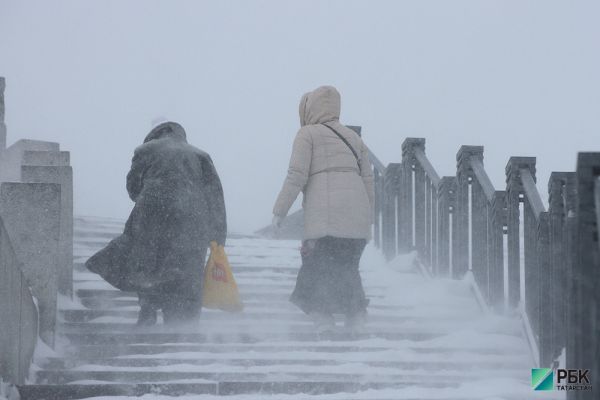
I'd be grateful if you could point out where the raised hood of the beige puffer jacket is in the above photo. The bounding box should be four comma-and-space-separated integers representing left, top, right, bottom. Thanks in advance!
300, 86, 341, 126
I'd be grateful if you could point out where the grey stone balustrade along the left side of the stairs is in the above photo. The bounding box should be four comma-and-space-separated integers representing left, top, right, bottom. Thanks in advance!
0, 78, 73, 390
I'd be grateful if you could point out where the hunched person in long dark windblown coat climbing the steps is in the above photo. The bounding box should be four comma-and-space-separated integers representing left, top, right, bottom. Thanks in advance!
86, 122, 227, 325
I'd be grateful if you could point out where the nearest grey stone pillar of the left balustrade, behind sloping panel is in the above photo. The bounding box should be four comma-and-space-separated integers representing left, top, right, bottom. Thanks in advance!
0, 183, 61, 346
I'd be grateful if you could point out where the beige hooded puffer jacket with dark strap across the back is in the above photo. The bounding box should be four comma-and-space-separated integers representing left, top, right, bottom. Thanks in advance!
273, 86, 374, 239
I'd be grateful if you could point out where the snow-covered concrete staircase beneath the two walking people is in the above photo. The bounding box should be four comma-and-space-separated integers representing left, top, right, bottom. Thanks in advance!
20, 218, 533, 400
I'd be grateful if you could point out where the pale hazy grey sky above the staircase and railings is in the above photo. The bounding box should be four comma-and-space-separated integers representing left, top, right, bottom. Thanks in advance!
0, 0, 600, 232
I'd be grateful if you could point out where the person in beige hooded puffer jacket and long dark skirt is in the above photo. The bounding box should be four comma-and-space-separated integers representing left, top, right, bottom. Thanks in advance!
273, 86, 374, 330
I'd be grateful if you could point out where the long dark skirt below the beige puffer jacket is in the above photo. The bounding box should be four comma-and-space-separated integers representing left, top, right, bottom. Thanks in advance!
290, 236, 369, 315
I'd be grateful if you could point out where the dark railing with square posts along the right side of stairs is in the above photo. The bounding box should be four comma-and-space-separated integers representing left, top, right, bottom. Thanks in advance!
371, 138, 600, 390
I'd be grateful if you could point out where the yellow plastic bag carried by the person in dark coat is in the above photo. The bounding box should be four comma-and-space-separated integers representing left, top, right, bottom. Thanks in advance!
202, 242, 244, 311
